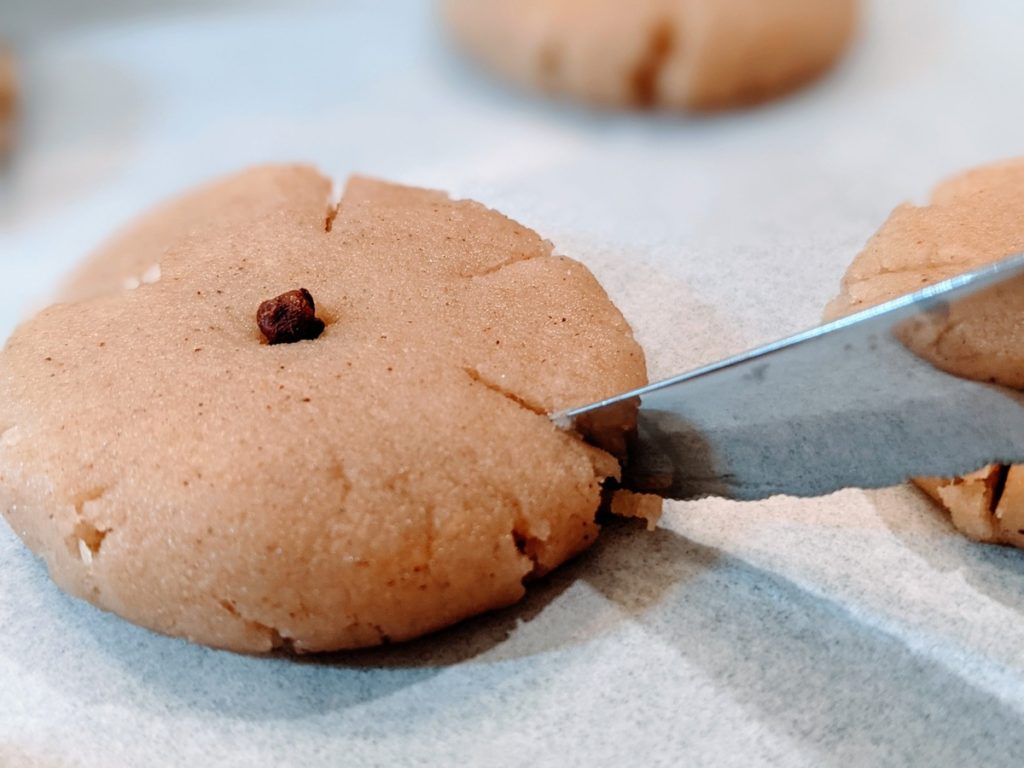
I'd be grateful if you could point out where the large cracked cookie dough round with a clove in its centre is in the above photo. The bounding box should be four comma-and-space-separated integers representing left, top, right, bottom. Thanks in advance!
0, 167, 646, 652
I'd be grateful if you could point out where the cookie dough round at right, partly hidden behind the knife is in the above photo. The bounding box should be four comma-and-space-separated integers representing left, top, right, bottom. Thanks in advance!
826, 160, 1024, 547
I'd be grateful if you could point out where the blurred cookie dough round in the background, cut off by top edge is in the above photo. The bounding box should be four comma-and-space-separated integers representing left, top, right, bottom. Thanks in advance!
442, 0, 857, 110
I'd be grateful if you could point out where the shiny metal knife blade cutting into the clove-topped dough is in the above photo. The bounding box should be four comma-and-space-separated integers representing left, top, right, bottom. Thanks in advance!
552, 254, 1024, 500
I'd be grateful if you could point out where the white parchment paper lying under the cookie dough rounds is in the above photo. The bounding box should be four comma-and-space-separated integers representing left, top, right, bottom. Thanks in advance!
0, 0, 1024, 766
